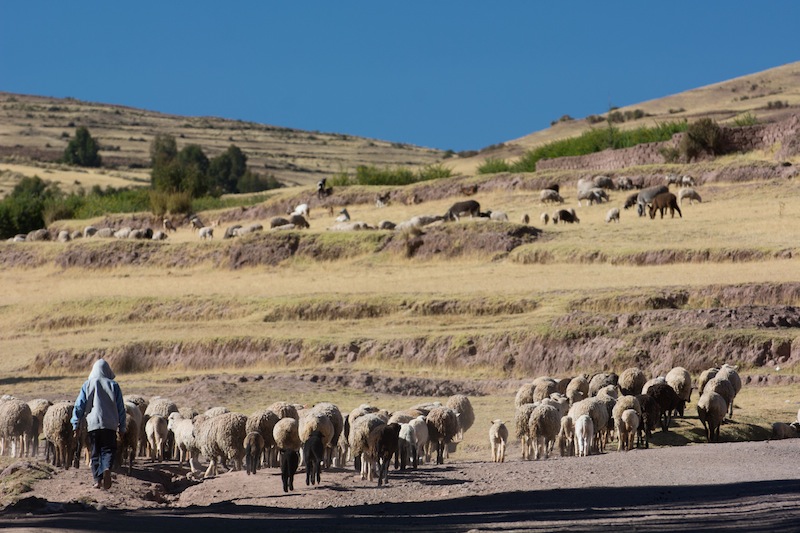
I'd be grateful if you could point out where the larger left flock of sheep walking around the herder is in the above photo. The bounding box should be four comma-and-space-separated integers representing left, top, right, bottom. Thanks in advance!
0, 394, 475, 492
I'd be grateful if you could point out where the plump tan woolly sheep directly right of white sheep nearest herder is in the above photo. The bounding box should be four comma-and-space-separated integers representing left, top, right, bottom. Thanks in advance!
196, 413, 247, 478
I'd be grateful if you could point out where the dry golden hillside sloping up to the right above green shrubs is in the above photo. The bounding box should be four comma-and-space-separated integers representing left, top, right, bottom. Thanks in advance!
448, 62, 800, 174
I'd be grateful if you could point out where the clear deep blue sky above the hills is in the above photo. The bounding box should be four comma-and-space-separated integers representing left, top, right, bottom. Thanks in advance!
0, 0, 800, 151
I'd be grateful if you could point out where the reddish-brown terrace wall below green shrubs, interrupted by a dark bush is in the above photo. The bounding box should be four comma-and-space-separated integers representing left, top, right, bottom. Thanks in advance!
536, 115, 800, 171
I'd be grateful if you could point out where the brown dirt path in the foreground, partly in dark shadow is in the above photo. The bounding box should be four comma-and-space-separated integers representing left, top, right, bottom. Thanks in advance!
0, 440, 800, 532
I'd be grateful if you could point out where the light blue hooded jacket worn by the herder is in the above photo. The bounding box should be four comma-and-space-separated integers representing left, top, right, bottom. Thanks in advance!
71, 359, 125, 433
